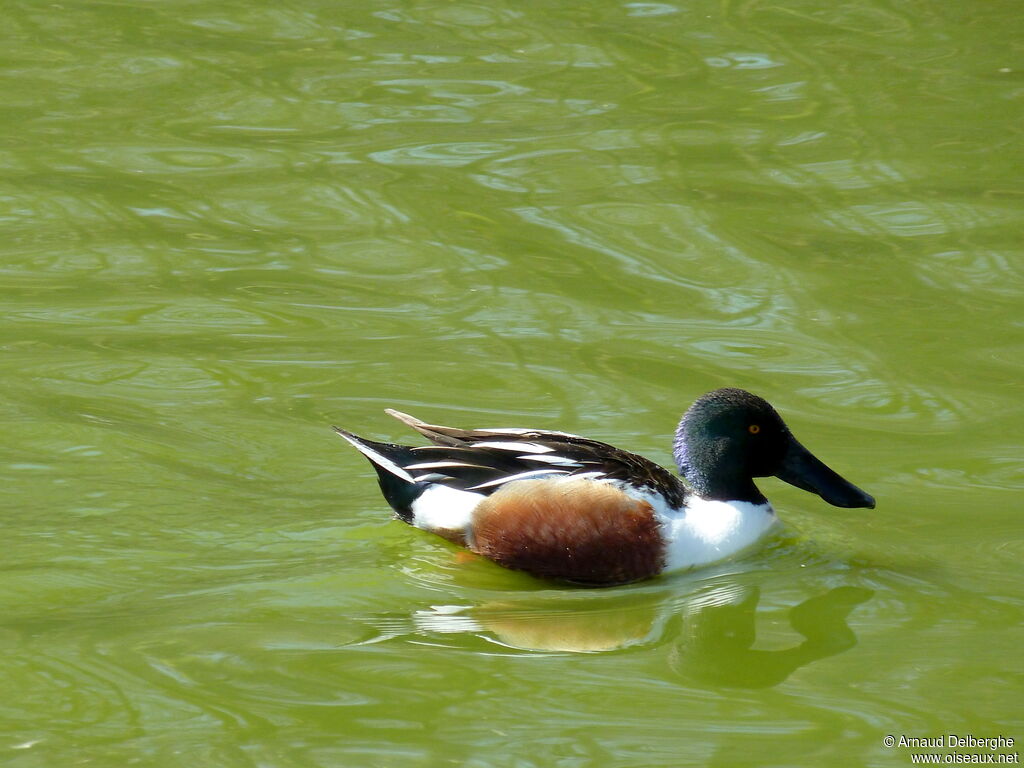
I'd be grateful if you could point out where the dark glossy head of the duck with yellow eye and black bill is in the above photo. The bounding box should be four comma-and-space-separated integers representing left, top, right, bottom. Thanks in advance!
673, 388, 874, 509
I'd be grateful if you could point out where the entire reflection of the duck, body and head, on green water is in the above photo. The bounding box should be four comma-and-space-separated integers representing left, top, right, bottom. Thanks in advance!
407, 583, 872, 688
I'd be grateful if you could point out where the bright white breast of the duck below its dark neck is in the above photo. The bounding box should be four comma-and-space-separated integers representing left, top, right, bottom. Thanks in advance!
655, 496, 778, 570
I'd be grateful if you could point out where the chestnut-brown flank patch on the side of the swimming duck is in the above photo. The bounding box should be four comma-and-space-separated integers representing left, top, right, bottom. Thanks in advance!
472, 480, 665, 586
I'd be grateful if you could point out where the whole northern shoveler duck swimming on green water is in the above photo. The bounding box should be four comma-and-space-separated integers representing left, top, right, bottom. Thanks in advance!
334, 387, 874, 587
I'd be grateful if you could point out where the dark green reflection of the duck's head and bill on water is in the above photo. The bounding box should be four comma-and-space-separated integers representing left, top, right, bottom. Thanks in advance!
670, 587, 873, 688
